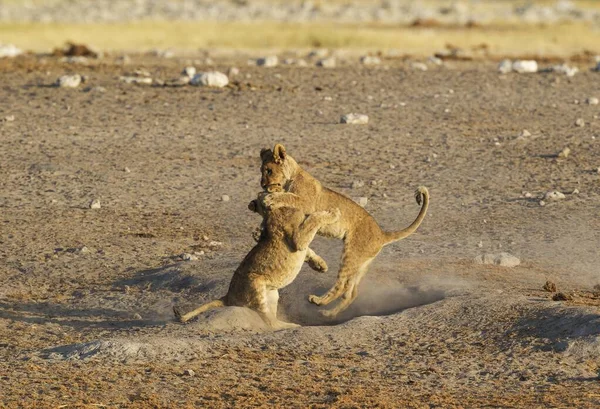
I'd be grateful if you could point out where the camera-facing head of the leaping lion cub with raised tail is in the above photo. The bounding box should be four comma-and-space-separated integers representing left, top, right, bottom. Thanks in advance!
260, 144, 298, 193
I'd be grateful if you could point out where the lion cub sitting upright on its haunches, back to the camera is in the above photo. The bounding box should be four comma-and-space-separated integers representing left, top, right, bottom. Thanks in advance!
173, 193, 340, 329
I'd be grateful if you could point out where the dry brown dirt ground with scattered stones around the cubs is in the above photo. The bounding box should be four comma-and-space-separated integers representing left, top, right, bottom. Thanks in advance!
0, 56, 600, 408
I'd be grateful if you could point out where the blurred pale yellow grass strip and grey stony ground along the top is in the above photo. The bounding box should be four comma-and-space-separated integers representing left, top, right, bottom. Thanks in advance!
0, 0, 600, 57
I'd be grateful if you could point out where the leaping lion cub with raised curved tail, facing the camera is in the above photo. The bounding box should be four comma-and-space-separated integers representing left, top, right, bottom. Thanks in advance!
260, 144, 429, 317
